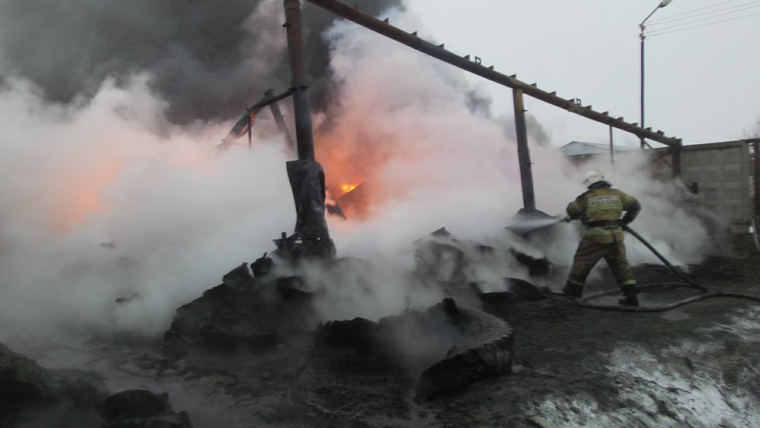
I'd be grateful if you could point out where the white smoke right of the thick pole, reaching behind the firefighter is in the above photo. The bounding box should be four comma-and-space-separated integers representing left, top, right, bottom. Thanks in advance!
312, 11, 712, 308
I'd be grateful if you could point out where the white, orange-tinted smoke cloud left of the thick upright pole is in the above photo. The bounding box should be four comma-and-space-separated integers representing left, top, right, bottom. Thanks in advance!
0, 78, 295, 334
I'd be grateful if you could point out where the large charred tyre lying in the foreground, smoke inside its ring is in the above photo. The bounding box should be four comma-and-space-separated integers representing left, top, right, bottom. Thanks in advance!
317, 298, 514, 399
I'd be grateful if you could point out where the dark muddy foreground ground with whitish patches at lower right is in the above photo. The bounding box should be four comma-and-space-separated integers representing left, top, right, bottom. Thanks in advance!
6, 239, 760, 428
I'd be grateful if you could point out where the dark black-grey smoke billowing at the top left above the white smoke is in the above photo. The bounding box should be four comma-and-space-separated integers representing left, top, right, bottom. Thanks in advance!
0, 0, 402, 124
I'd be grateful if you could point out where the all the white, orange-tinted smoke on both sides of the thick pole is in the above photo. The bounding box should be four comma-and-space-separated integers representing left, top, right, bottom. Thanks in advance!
0, 5, 728, 342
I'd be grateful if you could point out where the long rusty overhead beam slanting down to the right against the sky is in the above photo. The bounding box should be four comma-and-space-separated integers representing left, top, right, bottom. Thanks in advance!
306, 0, 681, 147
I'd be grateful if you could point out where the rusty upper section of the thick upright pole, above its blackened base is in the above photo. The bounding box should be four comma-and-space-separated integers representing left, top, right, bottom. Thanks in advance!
283, 0, 314, 160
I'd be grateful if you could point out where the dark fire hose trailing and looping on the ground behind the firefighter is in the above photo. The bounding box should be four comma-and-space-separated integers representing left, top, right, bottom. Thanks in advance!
578, 225, 760, 312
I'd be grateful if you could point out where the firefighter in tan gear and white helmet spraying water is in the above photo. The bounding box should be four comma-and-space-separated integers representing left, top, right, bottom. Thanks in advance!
562, 170, 641, 306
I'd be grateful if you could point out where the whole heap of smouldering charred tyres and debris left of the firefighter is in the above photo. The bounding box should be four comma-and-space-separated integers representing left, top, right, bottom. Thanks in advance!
165, 222, 548, 398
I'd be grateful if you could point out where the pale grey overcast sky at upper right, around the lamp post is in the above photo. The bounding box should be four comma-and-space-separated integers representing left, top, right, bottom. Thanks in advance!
406, 0, 760, 146
